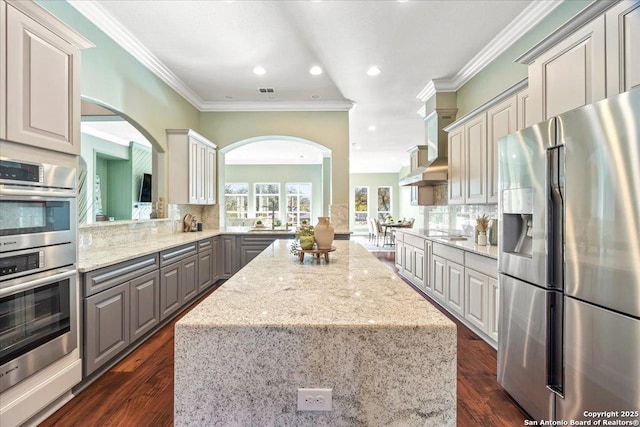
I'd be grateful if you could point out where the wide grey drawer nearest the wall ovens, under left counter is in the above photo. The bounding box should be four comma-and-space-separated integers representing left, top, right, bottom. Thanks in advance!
83, 254, 159, 297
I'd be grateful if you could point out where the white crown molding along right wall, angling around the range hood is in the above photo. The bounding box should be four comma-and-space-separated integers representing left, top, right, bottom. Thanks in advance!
416, 0, 562, 102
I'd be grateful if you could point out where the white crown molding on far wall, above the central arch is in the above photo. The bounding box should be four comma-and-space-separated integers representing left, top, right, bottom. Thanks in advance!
200, 101, 355, 111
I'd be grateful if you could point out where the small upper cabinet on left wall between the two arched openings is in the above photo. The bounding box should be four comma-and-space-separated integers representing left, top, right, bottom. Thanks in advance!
167, 129, 216, 205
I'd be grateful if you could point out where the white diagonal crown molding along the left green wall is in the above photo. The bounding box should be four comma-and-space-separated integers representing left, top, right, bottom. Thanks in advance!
67, 0, 203, 109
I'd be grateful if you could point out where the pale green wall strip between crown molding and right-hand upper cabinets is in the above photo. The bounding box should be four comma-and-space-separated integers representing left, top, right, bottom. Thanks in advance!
457, 0, 591, 118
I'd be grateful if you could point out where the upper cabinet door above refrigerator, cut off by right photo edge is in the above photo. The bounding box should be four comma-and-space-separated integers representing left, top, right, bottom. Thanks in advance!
606, 0, 640, 96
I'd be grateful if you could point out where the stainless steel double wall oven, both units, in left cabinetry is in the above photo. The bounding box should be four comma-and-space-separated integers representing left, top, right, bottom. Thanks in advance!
0, 157, 78, 392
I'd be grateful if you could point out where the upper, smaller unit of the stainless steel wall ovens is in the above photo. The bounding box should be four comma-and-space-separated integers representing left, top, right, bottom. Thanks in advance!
0, 157, 77, 252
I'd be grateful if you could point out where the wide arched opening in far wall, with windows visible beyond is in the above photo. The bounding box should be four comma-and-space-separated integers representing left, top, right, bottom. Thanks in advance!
219, 135, 331, 228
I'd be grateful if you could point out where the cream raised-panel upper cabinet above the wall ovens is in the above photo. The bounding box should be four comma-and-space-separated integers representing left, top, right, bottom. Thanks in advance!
0, 0, 92, 155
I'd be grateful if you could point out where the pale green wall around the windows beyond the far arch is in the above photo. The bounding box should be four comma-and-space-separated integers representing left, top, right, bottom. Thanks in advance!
226, 165, 323, 224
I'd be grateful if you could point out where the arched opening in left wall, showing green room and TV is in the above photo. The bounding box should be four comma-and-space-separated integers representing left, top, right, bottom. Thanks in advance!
78, 96, 164, 224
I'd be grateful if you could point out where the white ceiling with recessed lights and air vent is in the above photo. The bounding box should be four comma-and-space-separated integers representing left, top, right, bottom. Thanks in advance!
69, 0, 558, 173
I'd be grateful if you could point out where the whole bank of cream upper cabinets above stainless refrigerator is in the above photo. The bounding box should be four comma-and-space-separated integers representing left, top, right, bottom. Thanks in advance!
517, 0, 640, 124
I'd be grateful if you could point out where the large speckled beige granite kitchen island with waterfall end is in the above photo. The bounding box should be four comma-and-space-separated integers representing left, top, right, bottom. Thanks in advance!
174, 240, 456, 426
